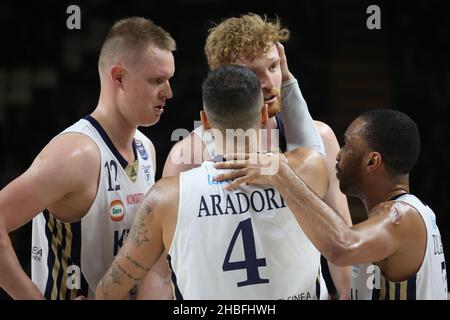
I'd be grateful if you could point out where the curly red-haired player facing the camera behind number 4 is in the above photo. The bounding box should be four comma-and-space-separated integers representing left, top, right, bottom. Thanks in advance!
155, 14, 351, 299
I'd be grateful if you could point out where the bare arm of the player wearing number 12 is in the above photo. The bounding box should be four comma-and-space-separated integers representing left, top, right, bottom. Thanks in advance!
0, 134, 100, 299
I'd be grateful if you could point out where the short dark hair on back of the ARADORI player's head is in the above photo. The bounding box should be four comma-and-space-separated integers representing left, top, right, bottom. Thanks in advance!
202, 65, 263, 130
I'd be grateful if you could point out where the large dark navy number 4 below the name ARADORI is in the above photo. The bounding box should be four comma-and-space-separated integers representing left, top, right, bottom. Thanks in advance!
222, 218, 269, 287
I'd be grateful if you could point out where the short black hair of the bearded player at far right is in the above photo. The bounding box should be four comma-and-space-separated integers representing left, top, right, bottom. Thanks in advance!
359, 109, 420, 175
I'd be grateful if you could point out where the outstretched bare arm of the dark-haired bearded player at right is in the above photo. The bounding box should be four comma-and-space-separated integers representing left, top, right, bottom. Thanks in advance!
223, 162, 426, 281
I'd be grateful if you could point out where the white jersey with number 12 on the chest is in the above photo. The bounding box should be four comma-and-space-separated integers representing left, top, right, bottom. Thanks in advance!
31, 116, 154, 299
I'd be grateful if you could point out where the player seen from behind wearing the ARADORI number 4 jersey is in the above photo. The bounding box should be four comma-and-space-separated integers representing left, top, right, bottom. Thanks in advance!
96, 65, 328, 299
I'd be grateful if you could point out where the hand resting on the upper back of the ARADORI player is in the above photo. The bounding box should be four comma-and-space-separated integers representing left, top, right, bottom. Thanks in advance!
214, 153, 287, 190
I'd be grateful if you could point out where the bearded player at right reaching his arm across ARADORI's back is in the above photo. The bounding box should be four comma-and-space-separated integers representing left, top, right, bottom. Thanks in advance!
217, 110, 447, 300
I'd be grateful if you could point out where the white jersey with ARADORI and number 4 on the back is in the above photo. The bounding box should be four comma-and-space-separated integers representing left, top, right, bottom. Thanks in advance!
168, 161, 328, 300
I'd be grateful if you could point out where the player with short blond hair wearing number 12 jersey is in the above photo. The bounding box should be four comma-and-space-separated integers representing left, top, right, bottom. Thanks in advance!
0, 18, 175, 299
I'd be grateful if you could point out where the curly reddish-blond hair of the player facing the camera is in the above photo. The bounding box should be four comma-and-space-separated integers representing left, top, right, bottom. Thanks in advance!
205, 13, 289, 70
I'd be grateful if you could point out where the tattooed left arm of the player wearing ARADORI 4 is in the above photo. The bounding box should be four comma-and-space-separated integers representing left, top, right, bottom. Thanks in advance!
95, 177, 178, 299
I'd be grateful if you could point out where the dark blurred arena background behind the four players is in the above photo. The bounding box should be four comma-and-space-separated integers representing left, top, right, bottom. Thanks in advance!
0, 0, 450, 298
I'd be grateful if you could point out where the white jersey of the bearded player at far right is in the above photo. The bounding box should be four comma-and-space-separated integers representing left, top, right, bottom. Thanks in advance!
351, 194, 447, 300
